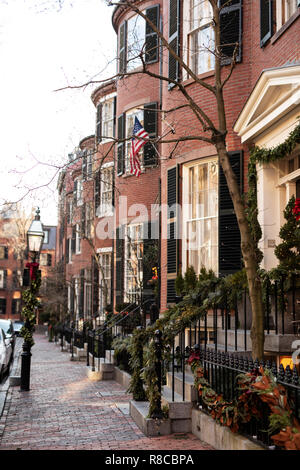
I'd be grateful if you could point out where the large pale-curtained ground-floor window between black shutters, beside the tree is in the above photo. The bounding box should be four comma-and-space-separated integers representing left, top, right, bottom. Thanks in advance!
183, 160, 218, 273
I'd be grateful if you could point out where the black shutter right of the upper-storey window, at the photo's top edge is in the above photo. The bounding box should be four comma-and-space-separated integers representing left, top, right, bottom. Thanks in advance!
220, 0, 242, 65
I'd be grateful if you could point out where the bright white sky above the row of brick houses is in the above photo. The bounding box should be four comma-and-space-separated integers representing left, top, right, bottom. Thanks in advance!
0, 0, 117, 224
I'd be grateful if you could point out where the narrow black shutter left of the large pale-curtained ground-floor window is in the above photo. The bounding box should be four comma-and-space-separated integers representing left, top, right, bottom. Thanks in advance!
167, 166, 178, 302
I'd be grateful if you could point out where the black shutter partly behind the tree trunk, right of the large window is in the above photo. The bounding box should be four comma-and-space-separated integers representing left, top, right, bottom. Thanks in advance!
219, 151, 243, 276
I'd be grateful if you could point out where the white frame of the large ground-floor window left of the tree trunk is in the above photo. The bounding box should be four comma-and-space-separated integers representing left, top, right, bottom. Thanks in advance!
182, 157, 219, 274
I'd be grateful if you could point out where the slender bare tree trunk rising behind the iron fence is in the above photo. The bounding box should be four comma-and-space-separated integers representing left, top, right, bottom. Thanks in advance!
215, 137, 264, 360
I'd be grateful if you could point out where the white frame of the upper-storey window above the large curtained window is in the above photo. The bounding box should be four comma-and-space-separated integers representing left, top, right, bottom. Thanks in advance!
183, 0, 215, 79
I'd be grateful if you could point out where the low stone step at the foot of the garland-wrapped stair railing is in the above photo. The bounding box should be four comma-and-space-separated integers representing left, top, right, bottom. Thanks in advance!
129, 400, 171, 437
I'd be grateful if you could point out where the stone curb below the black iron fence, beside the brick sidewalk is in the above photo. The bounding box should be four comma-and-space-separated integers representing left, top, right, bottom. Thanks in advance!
192, 409, 265, 450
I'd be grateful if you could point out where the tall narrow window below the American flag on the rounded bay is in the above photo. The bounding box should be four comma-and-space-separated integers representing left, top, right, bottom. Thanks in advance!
125, 224, 143, 302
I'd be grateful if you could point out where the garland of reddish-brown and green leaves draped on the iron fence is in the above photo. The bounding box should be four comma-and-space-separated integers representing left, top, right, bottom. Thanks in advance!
187, 353, 300, 450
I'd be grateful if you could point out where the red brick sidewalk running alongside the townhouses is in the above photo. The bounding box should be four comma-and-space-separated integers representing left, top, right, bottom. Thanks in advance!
0, 335, 211, 450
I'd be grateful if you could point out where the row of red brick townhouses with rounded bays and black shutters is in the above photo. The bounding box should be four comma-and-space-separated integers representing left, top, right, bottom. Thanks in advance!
58, 0, 300, 360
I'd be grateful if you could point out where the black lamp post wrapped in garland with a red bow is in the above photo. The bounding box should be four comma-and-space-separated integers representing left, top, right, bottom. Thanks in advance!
20, 208, 44, 391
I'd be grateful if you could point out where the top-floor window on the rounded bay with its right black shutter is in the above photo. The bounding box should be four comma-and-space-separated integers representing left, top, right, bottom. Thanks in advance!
119, 5, 159, 73
